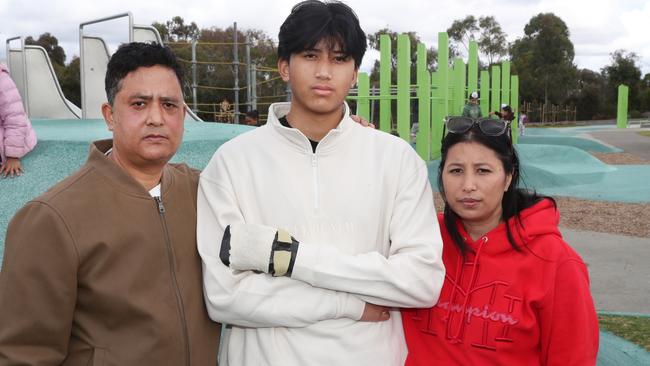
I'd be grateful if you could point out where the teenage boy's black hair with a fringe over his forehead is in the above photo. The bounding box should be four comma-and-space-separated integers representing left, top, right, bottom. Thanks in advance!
278, 0, 367, 69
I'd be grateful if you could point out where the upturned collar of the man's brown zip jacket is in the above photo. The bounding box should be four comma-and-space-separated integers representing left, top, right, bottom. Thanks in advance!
86, 139, 174, 198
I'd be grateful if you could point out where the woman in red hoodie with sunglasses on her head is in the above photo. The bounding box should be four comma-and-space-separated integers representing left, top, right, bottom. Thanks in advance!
402, 118, 598, 365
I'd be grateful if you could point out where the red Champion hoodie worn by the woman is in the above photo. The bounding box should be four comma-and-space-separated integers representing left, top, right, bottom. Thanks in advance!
402, 200, 598, 365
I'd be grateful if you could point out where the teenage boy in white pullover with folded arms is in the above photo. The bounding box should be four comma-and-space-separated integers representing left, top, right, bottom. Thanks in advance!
197, 0, 444, 366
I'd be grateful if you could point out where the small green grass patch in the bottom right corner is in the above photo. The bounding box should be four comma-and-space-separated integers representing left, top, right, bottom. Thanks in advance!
598, 314, 650, 352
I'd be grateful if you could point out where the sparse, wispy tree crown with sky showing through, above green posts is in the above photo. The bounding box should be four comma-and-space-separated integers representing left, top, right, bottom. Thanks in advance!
447, 15, 508, 65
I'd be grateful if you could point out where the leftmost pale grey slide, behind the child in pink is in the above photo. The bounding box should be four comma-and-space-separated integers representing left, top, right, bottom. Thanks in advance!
24, 45, 81, 119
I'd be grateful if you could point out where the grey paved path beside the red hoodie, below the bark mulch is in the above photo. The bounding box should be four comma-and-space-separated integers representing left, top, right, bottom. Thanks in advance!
561, 228, 650, 314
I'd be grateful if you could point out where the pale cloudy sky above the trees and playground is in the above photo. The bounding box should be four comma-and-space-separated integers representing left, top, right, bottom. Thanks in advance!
0, 0, 650, 74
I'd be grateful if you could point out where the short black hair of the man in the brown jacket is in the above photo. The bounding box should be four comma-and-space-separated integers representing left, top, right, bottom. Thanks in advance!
104, 42, 183, 105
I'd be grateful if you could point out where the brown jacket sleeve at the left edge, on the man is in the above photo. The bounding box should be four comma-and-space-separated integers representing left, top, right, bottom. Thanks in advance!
0, 202, 78, 365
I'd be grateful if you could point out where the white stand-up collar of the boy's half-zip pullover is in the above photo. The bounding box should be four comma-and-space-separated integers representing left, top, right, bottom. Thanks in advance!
267, 102, 355, 155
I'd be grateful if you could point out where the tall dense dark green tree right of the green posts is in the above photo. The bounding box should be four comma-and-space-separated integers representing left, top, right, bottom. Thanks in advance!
510, 13, 578, 104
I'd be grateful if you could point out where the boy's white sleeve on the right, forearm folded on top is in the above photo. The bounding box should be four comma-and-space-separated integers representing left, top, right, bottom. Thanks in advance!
291, 159, 445, 308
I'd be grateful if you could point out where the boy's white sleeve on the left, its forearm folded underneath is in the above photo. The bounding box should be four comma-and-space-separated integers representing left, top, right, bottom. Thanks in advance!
197, 153, 365, 327
